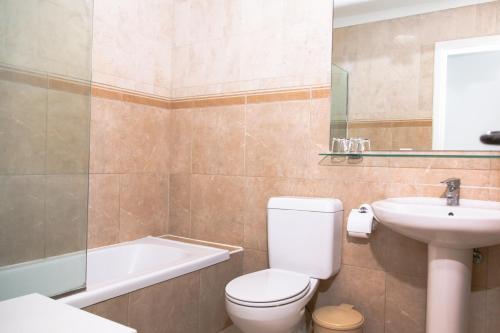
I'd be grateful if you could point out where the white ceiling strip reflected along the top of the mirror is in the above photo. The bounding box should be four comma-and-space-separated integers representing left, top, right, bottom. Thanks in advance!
333, 0, 495, 28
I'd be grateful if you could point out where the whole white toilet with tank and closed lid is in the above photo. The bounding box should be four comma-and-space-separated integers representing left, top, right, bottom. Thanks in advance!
226, 197, 343, 333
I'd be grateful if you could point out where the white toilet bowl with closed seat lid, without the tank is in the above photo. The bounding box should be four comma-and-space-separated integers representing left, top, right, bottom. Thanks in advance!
226, 269, 319, 333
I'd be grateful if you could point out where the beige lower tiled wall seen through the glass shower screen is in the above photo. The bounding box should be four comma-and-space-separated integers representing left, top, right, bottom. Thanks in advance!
0, 67, 90, 266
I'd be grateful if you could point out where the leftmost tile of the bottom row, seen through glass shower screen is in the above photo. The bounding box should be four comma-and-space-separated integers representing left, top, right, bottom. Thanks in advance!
0, 176, 45, 266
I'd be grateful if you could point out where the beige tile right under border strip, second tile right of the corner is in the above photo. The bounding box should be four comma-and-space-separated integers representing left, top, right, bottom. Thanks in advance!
192, 106, 245, 175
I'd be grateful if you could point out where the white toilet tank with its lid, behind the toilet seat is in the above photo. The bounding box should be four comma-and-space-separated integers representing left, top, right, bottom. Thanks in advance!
267, 197, 343, 279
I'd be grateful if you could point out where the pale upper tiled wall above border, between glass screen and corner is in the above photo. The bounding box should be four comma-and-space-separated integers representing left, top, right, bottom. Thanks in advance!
92, 0, 174, 97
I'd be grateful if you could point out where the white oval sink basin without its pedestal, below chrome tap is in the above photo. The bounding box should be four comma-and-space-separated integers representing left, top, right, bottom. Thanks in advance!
372, 197, 500, 249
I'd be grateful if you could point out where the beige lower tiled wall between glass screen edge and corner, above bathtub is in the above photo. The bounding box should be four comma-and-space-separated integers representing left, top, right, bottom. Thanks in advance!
88, 89, 170, 248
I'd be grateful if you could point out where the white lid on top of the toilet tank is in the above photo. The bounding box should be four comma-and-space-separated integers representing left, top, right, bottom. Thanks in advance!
267, 197, 343, 213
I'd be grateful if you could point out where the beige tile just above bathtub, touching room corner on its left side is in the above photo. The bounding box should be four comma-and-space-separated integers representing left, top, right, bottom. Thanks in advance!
120, 174, 168, 242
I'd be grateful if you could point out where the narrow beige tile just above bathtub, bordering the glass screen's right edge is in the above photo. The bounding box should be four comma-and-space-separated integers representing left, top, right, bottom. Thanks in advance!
88, 174, 120, 248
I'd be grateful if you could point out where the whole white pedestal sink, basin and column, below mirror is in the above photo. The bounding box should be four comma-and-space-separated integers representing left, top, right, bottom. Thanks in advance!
372, 197, 500, 333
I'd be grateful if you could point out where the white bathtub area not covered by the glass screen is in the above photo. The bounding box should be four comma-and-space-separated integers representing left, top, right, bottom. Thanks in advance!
59, 237, 229, 308
